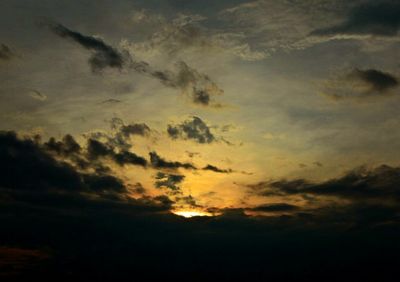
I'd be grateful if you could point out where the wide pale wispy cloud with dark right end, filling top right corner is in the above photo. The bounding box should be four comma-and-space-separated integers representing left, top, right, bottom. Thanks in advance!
220, 0, 400, 54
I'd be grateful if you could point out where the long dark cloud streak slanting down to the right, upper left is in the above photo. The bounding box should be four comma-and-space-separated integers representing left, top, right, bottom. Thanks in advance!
45, 23, 131, 73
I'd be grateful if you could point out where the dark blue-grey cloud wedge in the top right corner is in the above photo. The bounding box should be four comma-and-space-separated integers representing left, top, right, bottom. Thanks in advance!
311, 1, 400, 36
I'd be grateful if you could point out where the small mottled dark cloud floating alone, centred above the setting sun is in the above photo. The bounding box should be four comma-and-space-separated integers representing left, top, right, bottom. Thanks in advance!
167, 117, 216, 144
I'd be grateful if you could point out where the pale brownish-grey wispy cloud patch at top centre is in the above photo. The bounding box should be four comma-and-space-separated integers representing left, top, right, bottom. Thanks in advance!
129, 12, 266, 61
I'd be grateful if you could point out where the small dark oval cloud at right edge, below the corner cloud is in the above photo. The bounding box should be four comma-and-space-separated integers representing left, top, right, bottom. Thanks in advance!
348, 69, 399, 93
